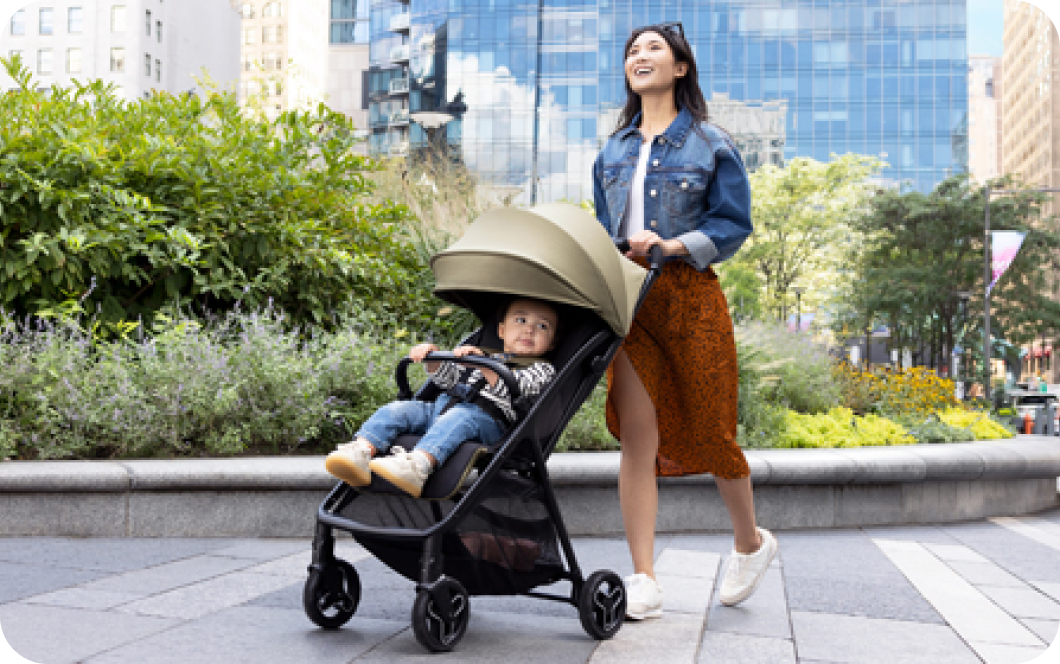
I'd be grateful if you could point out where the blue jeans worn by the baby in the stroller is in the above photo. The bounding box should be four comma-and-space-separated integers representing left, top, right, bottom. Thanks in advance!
356, 395, 505, 465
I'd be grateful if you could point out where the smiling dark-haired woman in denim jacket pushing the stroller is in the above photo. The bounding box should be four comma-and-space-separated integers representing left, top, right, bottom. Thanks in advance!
593, 23, 777, 619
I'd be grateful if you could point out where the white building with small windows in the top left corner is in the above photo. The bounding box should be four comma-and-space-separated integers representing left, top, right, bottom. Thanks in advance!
0, 0, 240, 99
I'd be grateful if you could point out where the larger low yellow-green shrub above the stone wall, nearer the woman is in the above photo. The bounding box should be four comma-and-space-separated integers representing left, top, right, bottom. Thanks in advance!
780, 407, 916, 448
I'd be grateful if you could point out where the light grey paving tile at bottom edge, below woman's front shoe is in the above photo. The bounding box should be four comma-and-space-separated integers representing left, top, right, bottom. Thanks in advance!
589, 613, 703, 664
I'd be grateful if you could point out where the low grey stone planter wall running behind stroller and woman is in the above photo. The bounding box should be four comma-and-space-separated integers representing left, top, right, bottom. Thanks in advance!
0, 435, 1060, 537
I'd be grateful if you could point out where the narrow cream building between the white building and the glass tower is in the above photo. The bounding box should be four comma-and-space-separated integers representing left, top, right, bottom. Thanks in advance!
239, 0, 331, 117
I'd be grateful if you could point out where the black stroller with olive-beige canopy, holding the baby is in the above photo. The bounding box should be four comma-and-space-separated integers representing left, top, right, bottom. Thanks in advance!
303, 204, 661, 651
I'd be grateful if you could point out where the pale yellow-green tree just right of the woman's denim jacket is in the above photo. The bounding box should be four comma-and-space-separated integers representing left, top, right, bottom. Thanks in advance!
740, 154, 883, 320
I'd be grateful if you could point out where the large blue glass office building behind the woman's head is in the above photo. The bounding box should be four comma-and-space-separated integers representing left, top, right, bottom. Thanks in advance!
370, 0, 968, 203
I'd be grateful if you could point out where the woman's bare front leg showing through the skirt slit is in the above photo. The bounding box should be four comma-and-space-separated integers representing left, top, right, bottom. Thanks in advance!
611, 350, 659, 578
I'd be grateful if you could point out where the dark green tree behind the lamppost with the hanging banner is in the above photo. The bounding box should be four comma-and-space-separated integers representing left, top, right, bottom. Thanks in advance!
848, 174, 1060, 375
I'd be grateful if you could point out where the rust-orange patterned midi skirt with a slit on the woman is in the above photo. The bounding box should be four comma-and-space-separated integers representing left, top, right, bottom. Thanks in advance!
607, 259, 750, 479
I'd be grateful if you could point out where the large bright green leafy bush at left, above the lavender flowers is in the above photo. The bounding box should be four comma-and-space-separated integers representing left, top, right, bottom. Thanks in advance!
0, 58, 449, 335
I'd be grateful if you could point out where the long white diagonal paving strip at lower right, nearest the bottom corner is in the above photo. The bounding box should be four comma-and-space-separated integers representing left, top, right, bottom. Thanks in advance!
876, 540, 1038, 646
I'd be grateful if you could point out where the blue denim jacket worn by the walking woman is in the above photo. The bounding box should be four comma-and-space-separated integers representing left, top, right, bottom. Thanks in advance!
593, 109, 753, 272
